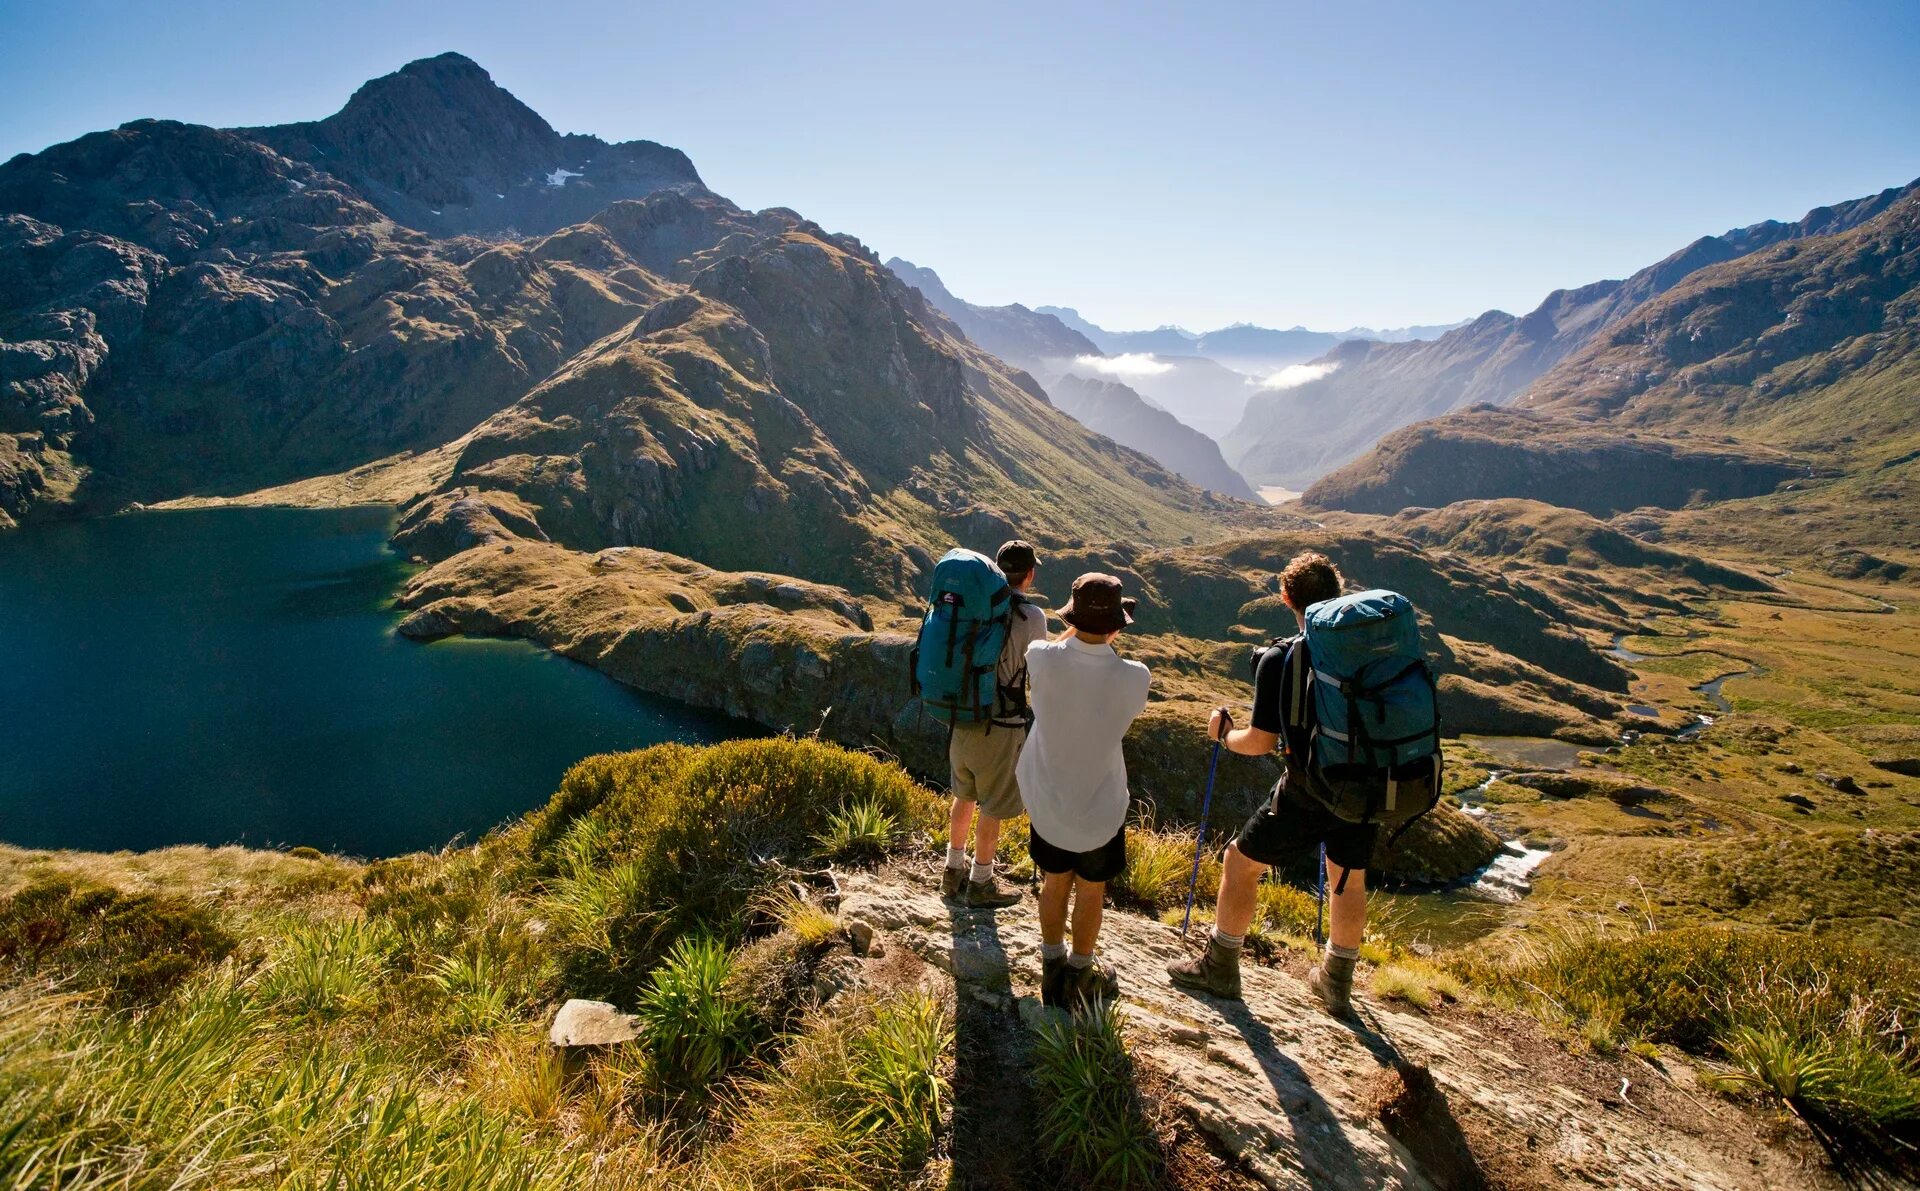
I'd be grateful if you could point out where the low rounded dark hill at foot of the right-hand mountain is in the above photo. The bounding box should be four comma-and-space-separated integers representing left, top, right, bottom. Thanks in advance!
1302, 407, 1811, 517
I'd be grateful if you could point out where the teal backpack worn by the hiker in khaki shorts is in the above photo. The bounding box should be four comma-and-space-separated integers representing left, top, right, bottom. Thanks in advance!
912, 549, 1014, 724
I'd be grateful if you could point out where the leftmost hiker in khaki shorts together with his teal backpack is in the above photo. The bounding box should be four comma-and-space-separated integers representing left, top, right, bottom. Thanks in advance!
916, 540, 1046, 909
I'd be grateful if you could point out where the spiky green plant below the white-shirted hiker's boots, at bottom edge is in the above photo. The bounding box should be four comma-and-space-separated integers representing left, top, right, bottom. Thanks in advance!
1033, 1005, 1160, 1187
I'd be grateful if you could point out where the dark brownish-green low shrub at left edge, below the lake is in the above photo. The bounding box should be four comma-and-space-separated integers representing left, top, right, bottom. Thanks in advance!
0, 878, 236, 1005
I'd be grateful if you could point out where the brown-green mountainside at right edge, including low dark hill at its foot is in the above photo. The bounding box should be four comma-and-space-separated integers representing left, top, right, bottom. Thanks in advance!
1306, 184, 1920, 551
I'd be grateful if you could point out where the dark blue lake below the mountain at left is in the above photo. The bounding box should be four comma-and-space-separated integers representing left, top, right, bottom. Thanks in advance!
0, 507, 745, 857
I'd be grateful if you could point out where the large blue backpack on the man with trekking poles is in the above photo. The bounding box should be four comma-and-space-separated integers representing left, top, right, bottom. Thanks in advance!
1296, 590, 1442, 834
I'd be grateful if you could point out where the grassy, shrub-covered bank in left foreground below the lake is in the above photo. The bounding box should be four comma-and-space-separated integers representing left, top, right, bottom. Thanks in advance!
0, 740, 952, 1191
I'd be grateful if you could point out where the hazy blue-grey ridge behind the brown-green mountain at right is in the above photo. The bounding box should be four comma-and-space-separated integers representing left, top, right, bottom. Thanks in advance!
1225, 177, 1905, 488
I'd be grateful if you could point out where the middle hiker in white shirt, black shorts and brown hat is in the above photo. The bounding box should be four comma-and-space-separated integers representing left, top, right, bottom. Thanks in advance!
1020, 572, 1150, 1009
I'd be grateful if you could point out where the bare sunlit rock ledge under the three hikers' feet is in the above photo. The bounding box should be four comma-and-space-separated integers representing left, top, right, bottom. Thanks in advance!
841, 870, 1837, 1191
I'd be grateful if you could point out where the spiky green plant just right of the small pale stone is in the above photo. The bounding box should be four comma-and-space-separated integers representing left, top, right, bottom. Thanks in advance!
637, 937, 762, 1091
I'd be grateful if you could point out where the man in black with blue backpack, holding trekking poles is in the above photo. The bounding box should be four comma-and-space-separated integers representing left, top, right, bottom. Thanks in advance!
1167, 551, 1440, 1016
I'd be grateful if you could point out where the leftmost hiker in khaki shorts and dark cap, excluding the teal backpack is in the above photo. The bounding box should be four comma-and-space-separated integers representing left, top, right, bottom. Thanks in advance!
941, 540, 1046, 909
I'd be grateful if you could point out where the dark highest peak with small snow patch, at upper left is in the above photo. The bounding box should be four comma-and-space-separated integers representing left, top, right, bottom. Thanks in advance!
234, 54, 701, 236
